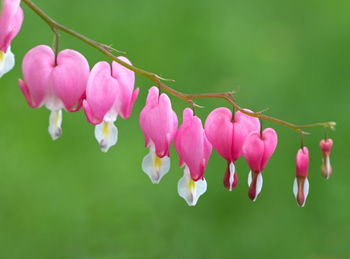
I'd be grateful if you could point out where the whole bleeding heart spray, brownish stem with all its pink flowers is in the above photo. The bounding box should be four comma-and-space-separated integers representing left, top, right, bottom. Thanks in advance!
0, 0, 335, 207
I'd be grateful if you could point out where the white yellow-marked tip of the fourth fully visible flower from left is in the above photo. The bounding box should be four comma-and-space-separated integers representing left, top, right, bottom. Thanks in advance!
177, 165, 207, 206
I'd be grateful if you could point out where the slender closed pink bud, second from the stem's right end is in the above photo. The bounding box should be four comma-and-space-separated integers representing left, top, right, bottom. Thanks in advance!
293, 147, 309, 207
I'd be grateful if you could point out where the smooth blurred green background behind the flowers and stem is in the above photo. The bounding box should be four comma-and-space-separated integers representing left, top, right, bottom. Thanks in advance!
0, 0, 350, 259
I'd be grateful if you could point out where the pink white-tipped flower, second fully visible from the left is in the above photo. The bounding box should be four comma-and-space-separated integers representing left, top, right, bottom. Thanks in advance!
83, 57, 139, 152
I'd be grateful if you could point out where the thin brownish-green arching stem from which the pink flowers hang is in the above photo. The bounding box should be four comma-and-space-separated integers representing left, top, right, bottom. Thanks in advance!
22, 0, 336, 135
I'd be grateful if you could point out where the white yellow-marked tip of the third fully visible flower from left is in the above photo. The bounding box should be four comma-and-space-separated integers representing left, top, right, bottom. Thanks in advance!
142, 143, 170, 184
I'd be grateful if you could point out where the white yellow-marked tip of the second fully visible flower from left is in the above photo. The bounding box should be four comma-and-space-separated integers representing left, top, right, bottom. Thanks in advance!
95, 121, 118, 152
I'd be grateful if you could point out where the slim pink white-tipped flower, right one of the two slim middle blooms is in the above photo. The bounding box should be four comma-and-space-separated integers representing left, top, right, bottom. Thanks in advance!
174, 108, 212, 206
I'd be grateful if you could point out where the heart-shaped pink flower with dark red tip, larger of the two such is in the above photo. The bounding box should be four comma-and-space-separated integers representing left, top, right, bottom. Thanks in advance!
205, 107, 260, 191
